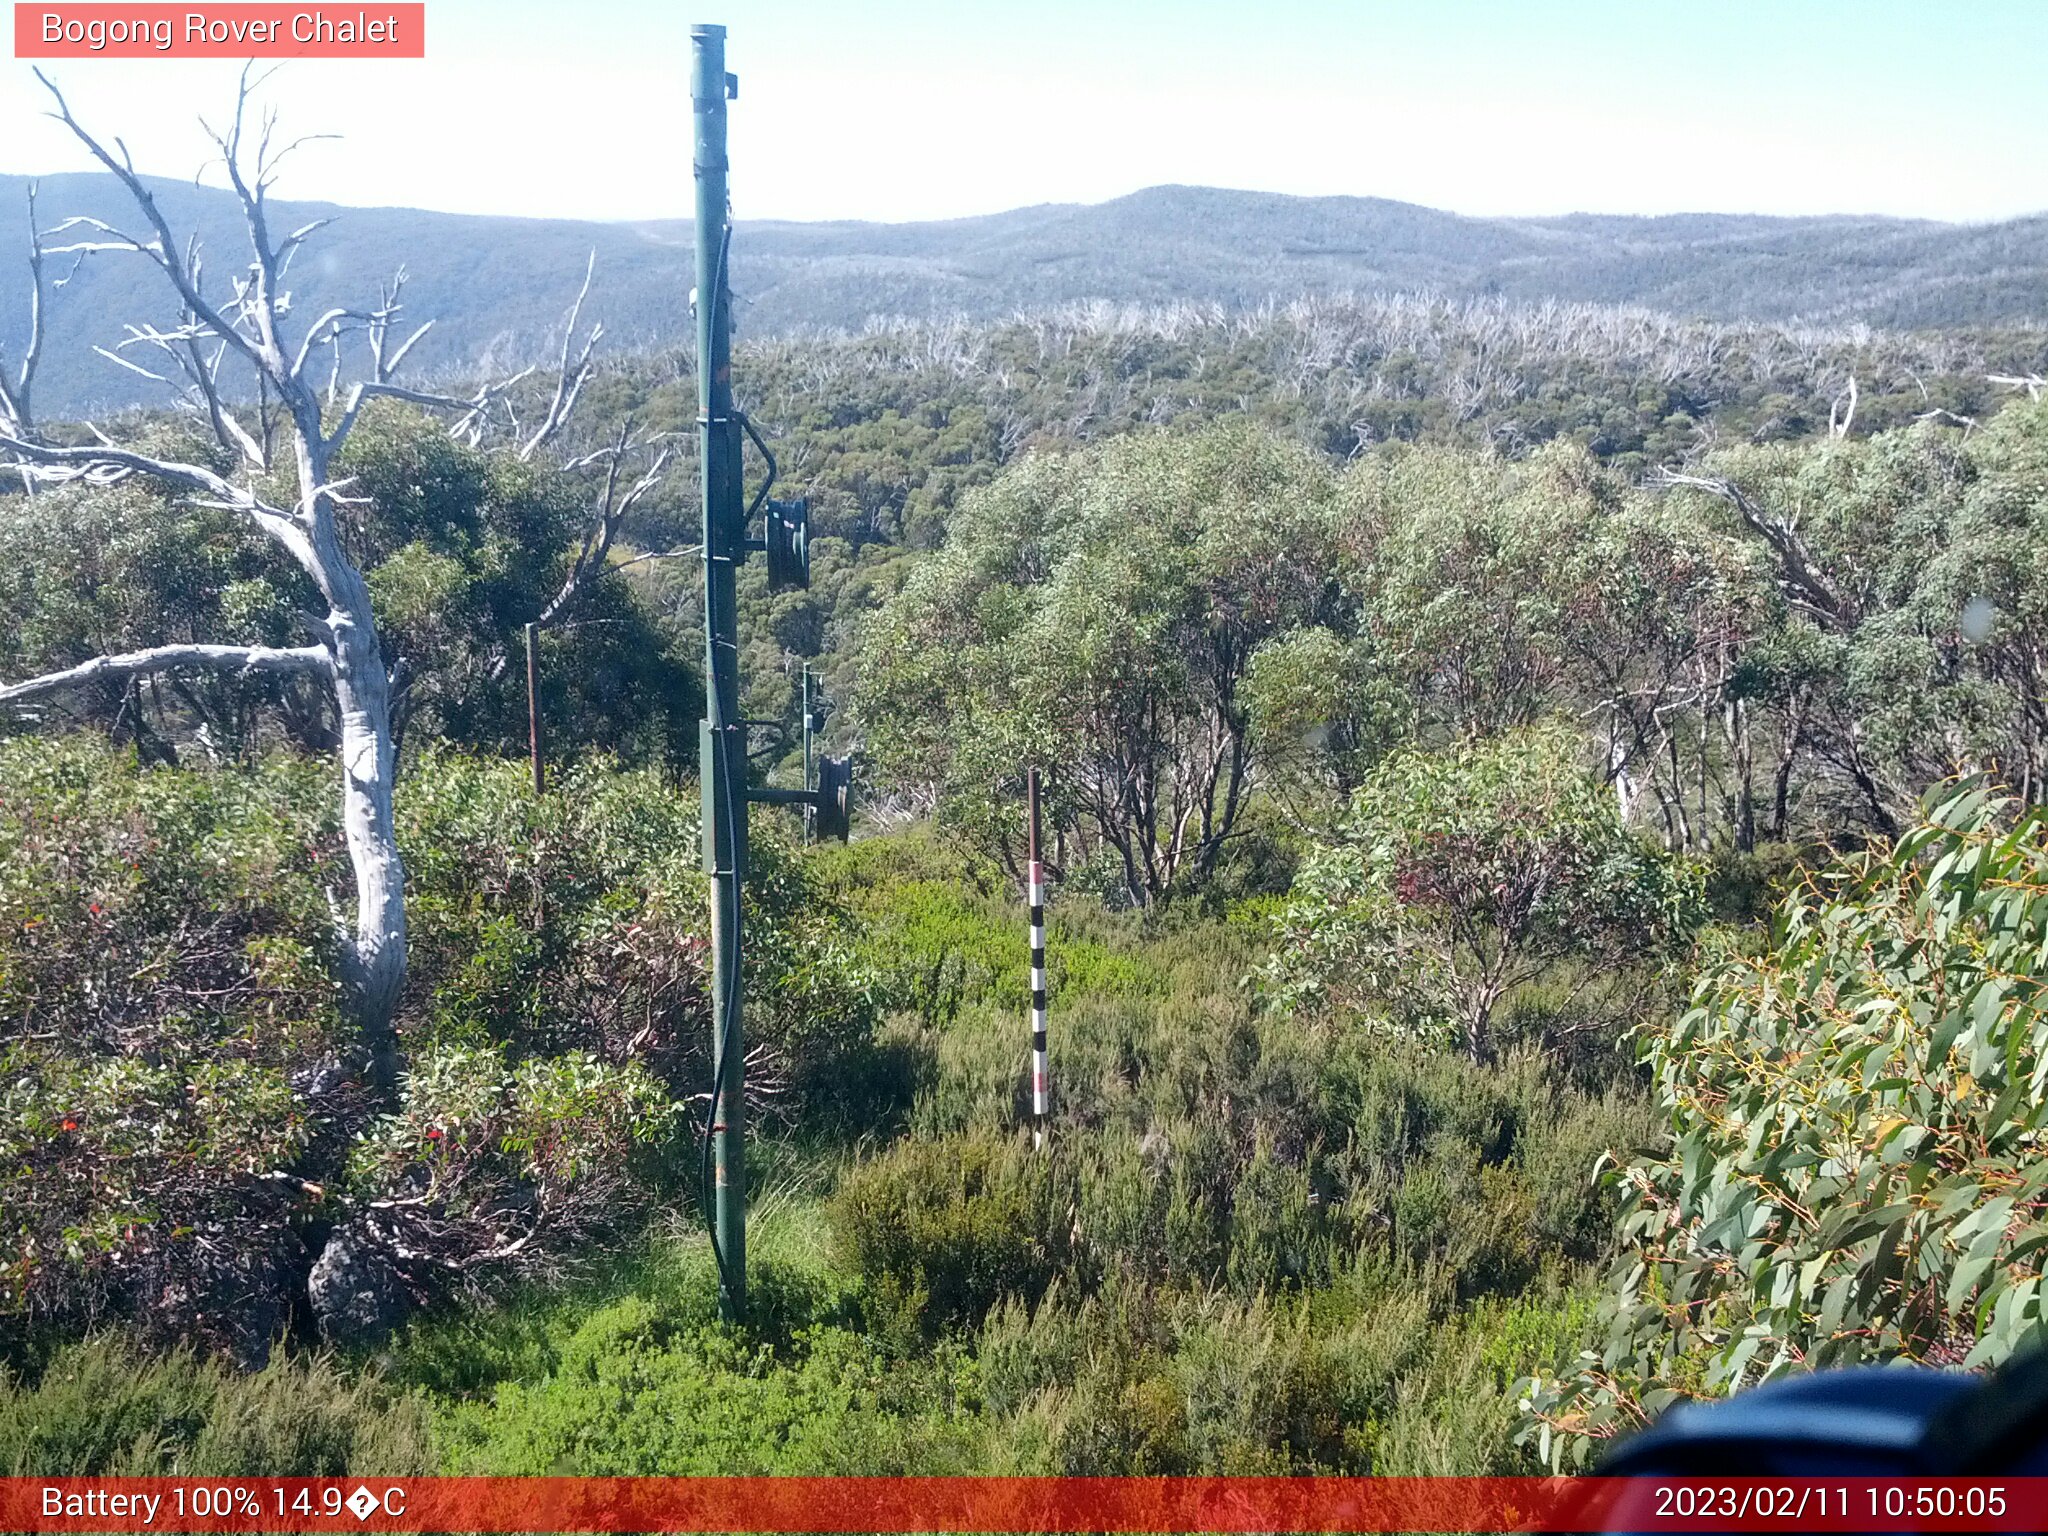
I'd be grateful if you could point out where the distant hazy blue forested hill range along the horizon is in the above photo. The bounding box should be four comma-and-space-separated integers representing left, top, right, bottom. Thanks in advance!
0, 174, 2048, 412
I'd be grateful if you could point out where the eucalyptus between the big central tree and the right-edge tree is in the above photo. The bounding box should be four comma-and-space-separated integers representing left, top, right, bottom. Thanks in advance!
1329, 442, 1765, 848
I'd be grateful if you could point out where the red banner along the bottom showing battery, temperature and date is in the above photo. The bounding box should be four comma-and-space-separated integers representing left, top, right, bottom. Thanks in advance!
0, 1477, 2048, 1536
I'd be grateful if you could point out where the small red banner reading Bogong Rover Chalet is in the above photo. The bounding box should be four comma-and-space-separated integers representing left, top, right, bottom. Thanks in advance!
14, 0, 426, 59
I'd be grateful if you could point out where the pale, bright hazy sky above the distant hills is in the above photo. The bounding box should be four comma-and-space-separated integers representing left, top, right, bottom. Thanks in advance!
0, 0, 2048, 219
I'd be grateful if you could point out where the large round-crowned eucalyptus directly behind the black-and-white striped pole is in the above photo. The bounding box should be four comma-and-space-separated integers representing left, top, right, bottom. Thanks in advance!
858, 426, 1343, 903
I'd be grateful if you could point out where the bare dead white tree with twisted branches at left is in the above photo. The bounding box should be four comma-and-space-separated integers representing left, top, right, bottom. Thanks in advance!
0, 72, 548, 1087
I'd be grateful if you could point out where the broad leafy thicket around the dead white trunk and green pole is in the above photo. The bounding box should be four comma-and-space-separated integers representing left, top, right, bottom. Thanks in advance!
0, 737, 880, 1362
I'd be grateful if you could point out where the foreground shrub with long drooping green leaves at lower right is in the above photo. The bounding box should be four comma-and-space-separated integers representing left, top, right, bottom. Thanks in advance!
1528, 784, 2048, 1462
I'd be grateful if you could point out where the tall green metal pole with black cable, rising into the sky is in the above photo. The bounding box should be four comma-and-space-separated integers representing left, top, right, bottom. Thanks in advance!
690, 25, 748, 1319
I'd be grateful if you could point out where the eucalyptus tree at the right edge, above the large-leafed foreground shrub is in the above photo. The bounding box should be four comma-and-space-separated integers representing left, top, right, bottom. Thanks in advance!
1663, 401, 2048, 836
